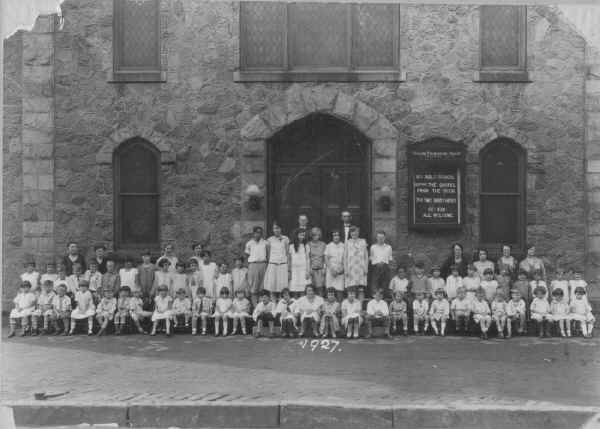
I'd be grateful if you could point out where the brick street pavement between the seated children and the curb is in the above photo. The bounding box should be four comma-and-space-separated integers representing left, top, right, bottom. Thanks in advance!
0, 335, 600, 406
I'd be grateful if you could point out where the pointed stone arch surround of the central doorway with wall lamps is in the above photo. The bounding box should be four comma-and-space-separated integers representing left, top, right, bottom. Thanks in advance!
238, 84, 399, 244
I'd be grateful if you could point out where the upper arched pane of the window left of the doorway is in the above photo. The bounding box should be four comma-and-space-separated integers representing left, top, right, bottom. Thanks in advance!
119, 144, 158, 193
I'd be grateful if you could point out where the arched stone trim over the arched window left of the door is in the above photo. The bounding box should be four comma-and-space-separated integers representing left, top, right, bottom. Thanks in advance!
96, 127, 176, 164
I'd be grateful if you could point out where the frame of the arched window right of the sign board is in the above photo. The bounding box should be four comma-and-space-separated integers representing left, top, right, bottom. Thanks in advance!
479, 137, 527, 254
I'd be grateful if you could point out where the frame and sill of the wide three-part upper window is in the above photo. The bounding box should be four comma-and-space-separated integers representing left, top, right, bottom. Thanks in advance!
234, 2, 406, 82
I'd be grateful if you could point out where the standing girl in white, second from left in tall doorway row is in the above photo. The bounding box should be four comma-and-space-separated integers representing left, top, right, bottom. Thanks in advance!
264, 223, 290, 292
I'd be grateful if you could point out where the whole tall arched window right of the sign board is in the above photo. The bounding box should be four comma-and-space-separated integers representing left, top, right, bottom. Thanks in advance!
479, 138, 526, 251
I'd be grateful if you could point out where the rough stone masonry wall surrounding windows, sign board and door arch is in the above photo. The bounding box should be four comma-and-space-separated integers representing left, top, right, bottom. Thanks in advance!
0, 0, 585, 308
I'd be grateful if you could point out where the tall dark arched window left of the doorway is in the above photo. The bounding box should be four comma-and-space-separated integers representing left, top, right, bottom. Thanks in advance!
114, 137, 160, 248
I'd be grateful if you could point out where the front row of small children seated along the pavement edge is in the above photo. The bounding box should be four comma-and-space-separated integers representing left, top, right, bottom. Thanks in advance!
9, 280, 595, 339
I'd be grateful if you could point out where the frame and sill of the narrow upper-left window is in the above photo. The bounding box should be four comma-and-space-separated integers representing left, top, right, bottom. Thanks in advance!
109, 0, 166, 83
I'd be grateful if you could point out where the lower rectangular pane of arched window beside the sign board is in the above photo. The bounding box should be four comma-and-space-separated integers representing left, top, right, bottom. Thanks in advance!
481, 195, 519, 243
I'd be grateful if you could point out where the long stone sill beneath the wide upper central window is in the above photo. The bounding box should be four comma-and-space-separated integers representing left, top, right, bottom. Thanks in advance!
233, 70, 406, 82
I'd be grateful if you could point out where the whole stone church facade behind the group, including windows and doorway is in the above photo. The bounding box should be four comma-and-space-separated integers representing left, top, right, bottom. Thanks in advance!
3, 0, 600, 307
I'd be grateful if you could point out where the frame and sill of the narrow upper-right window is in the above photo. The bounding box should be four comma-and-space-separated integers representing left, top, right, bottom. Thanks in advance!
474, 5, 531, 82
